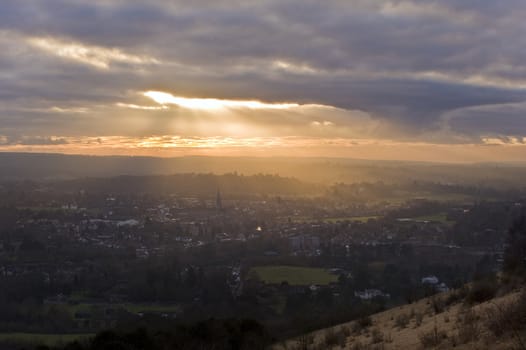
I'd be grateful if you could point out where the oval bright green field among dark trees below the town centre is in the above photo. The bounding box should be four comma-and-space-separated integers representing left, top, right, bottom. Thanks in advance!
249, 266, 338, 286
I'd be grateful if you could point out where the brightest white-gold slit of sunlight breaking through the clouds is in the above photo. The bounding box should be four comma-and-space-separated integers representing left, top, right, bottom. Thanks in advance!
143, 91, 300, 110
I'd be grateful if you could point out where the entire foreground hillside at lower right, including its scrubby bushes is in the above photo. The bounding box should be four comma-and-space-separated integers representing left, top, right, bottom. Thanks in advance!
274, 289, 526, 350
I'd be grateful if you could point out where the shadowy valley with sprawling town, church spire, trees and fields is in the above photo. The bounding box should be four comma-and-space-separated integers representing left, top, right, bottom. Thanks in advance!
0, 174, 526, 336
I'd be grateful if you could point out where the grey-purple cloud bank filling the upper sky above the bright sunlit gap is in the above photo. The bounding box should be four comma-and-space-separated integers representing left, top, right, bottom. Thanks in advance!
0, 0, 526, 142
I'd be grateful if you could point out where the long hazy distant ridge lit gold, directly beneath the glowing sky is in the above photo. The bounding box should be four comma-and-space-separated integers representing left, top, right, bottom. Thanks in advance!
0, 152, 526, 188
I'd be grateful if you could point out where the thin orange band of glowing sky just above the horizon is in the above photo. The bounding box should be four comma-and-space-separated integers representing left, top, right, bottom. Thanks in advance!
0, 135, 526, 163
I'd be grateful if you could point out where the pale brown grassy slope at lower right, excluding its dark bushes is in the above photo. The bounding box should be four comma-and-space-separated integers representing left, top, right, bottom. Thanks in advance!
274, 292, 526, 350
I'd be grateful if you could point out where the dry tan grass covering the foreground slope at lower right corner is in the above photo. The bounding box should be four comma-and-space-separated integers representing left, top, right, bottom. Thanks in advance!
275, 292, 526, 350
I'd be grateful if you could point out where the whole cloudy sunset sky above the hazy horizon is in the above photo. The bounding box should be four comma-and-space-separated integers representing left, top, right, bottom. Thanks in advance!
0, 0, 526, 162
